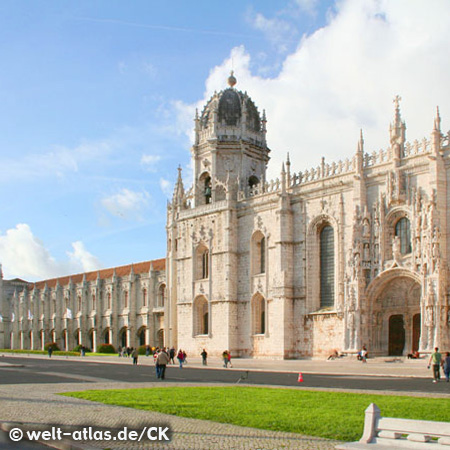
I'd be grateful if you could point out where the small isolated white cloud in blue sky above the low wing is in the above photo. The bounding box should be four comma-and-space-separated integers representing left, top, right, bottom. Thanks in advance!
101, 188, 150, 220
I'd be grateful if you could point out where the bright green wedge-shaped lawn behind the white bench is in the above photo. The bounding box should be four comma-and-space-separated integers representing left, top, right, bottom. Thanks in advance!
62, 386, 450, 441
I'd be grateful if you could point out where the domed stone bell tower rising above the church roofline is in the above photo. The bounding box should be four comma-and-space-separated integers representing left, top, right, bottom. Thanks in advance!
191, 72, 270, 206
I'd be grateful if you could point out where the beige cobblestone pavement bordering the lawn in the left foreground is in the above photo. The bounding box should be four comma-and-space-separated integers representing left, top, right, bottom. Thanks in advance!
0, 383, 337, 450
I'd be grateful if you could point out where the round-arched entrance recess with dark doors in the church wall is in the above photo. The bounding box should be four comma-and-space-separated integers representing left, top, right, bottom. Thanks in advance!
371, 277, 421, 356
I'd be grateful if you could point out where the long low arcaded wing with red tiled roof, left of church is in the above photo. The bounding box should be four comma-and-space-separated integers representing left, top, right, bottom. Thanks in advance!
0, 259, 166, 351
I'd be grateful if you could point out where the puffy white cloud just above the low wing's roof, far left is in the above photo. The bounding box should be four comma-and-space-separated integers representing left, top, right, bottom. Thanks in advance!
0, 223, 101, 281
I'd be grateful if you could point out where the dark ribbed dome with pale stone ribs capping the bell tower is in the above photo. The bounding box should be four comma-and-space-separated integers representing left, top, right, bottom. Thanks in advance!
196, 72, 266, 145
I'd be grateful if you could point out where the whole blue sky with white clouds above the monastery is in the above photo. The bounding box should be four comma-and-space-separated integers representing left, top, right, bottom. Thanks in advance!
0, 0, 450, 281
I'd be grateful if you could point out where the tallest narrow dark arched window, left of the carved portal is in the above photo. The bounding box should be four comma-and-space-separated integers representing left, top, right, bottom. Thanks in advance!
320, 225, 334, 308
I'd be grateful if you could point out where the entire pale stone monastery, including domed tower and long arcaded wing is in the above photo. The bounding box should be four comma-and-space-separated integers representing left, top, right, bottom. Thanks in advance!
0, 76, 450, 358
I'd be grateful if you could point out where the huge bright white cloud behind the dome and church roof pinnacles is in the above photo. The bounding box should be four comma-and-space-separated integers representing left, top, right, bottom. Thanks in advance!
174, 0, 450, 178
